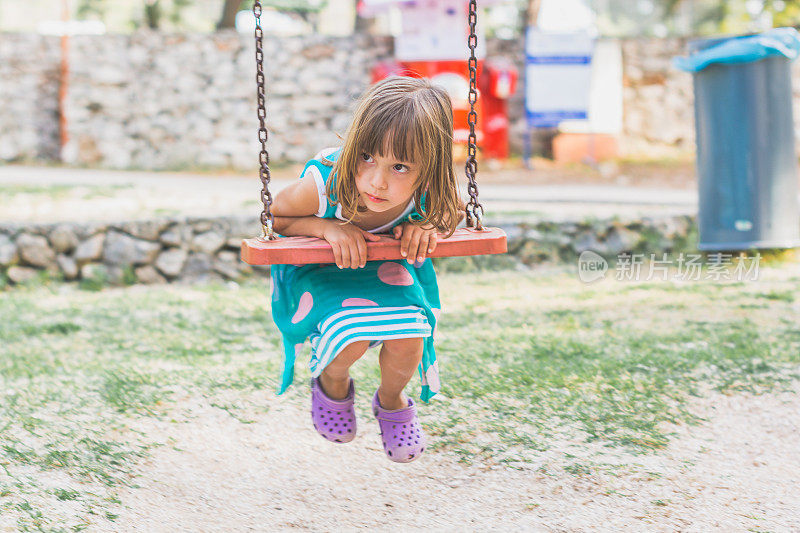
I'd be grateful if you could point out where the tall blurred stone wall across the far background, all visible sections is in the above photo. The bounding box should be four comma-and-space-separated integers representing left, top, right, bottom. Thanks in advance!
6, 31, 800, 169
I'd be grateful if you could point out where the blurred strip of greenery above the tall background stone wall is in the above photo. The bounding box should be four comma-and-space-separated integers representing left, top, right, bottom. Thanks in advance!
6, 0, 800, 39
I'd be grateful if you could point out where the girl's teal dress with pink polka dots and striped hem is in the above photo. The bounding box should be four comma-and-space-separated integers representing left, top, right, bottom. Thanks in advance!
271, 149, 441, 402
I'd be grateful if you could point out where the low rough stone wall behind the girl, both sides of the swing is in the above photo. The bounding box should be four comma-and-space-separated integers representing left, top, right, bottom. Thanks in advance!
0, 212, 695, 287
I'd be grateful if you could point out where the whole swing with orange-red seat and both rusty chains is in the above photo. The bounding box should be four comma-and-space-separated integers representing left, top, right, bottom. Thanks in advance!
241, 0, 507, 265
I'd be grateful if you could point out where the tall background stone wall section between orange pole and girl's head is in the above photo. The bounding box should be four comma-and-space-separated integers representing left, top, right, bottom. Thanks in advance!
64, 32, 391, 169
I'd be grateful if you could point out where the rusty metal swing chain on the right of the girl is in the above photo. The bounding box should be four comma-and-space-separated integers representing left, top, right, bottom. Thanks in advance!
464, 0, 483, 230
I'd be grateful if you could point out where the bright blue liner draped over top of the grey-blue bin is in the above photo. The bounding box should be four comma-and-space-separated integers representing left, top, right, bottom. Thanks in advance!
672, 28, 800, 72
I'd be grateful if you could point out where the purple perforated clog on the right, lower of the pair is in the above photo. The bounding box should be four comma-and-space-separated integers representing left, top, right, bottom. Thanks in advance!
372, 391, 425, 463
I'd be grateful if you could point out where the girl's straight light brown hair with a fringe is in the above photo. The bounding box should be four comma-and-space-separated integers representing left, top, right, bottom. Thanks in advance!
327, 76, 460, 235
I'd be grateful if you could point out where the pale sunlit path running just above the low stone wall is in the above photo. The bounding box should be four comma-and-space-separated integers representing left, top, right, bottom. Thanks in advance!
0, 165, 708, 222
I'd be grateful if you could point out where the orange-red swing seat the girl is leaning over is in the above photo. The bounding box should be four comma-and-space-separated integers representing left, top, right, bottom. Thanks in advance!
242, 228, 508, 265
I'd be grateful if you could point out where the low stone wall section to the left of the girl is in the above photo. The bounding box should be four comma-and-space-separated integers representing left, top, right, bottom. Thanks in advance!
0, 217, 266, 285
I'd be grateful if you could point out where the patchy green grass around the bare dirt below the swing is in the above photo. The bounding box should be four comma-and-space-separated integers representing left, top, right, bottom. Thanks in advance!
0, 263, 800, 531
